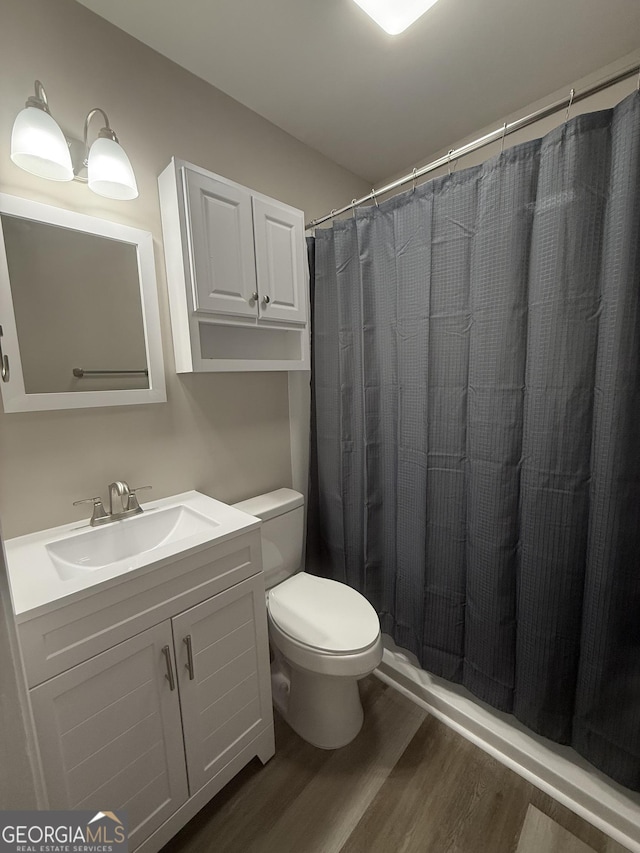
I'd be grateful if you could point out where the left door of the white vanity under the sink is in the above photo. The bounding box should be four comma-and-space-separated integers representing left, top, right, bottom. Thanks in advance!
30, 620, 188, 849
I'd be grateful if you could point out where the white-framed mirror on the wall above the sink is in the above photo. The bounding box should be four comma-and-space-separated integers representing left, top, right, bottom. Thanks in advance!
0, 193, 166, 413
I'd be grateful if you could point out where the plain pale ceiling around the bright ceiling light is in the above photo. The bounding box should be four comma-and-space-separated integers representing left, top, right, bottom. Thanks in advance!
74, 0, 640, 186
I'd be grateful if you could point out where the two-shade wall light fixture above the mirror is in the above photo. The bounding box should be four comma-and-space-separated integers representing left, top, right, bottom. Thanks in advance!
11, 80, 138, 200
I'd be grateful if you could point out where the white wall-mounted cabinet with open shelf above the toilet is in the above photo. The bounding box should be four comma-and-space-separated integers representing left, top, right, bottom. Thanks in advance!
158, 158, 309, 373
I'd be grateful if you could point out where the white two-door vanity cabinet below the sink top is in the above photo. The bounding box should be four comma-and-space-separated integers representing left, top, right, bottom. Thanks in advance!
18, 530, 274, 853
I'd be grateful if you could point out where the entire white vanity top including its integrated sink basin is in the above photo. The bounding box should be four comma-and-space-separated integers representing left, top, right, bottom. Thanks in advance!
5, 492, 260, 622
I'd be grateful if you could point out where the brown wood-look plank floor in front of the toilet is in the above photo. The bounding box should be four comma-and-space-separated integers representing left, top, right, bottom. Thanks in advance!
163, 676, 625, 853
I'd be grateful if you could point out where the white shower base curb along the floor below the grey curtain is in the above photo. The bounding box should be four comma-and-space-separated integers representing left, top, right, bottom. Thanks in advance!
374, 637, 640, 853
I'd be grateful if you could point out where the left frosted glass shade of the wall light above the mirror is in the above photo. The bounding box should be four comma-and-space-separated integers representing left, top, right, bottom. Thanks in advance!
11, 107, 73, 181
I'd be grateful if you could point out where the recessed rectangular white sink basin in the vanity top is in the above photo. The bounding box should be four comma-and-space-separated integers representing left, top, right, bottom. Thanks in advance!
45, 504, 220, 580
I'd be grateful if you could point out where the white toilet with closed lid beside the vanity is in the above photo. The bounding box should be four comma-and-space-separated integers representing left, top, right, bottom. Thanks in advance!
235, 489, 382, 749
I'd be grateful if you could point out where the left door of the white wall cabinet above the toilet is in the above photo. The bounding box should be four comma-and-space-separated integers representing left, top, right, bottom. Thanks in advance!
182, 168, 258, 317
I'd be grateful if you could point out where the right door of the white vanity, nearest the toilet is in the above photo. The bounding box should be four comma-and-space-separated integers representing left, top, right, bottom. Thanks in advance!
173, 575, 273, 796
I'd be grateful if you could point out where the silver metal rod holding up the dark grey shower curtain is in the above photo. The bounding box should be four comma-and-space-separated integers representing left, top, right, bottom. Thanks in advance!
305, 64, 640, 231
